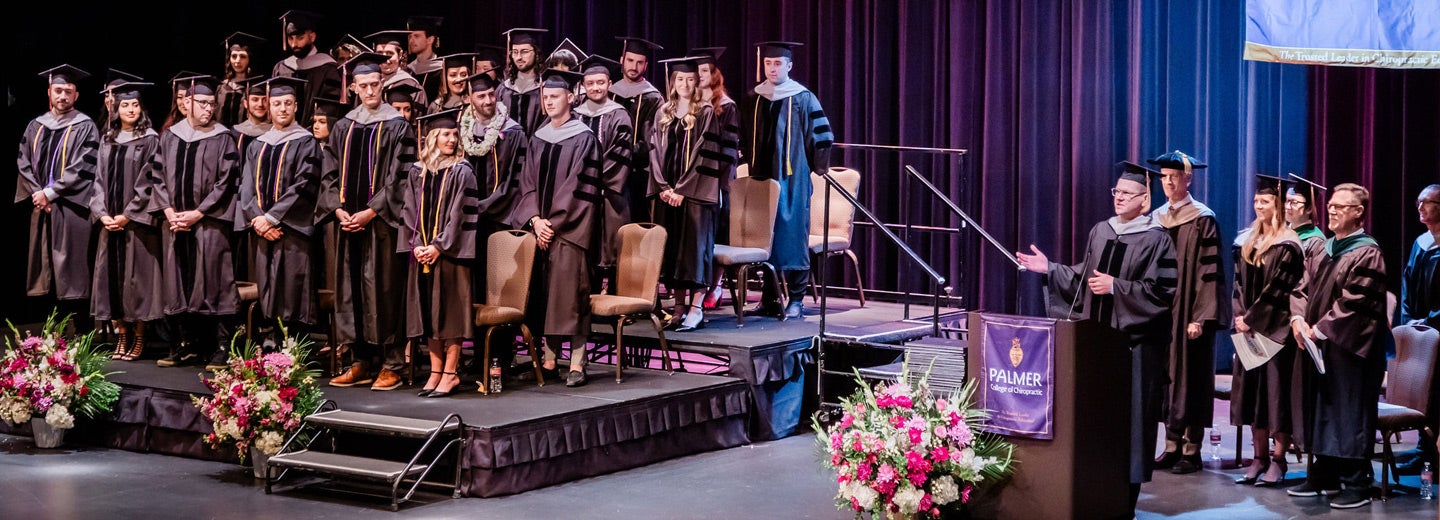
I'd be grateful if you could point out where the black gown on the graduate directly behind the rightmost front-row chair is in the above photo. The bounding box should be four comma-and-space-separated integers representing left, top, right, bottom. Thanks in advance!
575, 99, 635, 268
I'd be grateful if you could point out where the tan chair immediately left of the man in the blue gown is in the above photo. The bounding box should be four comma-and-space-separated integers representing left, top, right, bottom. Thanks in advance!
714, 176, 786, 327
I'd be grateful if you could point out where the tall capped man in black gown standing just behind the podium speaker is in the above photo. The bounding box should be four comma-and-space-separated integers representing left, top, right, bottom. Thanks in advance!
1149, 150, 1231, 474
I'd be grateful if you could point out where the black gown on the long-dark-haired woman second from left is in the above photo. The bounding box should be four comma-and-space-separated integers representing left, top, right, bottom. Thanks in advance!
89, 130, 166, 321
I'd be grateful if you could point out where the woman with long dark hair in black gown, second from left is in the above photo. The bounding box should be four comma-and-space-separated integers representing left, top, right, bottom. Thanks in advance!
89, 82, 166, 362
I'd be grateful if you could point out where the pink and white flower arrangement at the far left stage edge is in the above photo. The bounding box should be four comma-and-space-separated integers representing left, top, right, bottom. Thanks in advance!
0, 311, 120, 429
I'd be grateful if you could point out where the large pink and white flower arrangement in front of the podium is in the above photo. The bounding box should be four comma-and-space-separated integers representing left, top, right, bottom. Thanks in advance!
814, 370, 1015, 519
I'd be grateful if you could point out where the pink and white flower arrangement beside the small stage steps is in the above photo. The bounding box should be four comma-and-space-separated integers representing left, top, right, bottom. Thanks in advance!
193, 324, 321, 462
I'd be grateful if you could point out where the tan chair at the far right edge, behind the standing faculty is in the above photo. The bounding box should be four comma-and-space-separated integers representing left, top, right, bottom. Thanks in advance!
1375, 326, 1440, 500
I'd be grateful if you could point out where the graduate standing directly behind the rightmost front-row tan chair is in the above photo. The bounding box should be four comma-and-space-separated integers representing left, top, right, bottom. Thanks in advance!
575, 55, 635, 292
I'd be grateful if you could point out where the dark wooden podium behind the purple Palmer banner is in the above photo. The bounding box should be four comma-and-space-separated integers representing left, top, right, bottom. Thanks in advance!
966, 313, 1132, 519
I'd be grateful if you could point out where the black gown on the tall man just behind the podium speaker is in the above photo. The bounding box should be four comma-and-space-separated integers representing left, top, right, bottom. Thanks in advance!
1152, 197, 1231, 432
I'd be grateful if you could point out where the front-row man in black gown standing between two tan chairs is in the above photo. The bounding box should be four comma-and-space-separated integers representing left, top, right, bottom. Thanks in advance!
510, 71, 603, 386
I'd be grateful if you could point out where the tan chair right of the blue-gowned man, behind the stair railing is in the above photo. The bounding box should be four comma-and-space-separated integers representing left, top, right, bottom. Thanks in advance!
809, 167, 865, 307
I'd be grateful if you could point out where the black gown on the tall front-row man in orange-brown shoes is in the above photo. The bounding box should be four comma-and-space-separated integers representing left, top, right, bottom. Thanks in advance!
315, 104, 415, 346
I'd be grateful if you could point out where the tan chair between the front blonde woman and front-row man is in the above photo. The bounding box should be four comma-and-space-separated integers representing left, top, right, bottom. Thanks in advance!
475, 229, 544, 393
